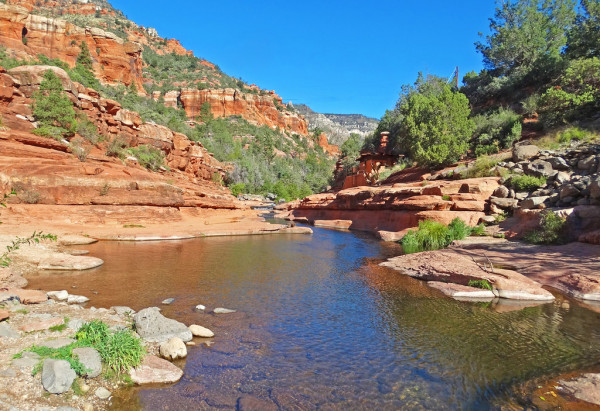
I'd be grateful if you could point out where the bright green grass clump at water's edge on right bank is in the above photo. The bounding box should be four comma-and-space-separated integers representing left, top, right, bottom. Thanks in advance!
400, 218, 480, 254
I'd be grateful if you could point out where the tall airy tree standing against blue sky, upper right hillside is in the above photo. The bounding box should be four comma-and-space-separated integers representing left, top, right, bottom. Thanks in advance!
475, 0, 576, 74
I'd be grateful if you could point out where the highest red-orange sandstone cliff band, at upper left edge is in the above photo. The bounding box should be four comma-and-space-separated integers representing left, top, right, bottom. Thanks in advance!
0, 4, 143, 90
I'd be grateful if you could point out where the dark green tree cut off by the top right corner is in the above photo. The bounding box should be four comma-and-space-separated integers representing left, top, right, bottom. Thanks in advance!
567, 0, 600, 58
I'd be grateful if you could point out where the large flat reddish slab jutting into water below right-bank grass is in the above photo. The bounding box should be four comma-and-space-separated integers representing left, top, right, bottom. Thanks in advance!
380, 249, 554, 301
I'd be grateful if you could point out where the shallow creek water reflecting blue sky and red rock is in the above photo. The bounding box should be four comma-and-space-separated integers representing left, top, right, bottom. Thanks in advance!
29, 228, 600, 410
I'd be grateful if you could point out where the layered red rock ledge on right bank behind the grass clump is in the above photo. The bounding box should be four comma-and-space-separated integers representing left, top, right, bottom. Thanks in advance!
288, 177, 499, 240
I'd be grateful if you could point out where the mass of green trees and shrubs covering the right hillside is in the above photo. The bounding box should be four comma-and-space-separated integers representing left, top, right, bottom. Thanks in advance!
364, 0, 600, 168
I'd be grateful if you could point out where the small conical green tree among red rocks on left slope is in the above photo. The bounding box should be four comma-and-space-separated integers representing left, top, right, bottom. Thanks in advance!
33, 70, 77, 138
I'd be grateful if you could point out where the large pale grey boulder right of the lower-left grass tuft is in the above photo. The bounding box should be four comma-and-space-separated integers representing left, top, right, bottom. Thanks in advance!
133, 307, 192, 343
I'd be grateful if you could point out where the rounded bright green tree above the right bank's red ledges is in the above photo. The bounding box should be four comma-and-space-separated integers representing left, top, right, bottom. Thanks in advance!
400, 85, 475, 167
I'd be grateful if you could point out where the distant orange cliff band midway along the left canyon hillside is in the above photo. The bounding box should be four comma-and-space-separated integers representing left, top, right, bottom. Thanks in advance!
154, 88, 308, 136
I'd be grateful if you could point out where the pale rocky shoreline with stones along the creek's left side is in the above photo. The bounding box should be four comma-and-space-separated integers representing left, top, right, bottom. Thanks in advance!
0, 214, 312, 410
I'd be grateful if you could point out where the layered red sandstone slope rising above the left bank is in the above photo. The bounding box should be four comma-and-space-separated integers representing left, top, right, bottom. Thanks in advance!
0, 66, 241, 211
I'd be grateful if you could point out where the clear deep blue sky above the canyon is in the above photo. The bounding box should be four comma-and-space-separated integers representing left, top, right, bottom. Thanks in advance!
111, 0, 495, 118
